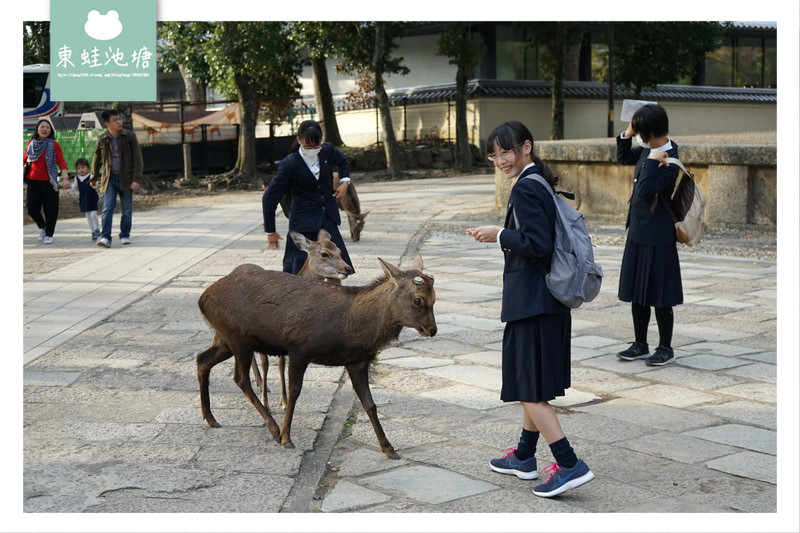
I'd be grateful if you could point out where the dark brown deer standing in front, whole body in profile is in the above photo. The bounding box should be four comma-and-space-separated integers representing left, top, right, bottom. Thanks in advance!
197, 256, 437, 459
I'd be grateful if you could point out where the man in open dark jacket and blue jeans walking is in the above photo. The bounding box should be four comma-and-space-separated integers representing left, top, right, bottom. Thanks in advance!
92, 109, 144, 248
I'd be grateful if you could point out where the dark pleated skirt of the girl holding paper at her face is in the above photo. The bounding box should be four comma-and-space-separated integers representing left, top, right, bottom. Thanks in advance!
617, 239, 683, 307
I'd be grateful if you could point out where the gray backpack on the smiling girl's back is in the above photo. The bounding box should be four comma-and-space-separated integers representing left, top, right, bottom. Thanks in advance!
523, 174, 603, 309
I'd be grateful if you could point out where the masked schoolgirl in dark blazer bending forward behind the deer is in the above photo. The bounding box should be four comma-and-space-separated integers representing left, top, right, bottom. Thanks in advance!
261, 120, 355, 281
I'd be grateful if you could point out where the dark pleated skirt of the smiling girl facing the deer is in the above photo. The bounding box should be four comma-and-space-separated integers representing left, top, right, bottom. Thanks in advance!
500, 313, 572, 402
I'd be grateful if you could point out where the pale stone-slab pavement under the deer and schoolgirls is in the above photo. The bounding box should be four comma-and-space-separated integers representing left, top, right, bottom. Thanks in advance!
15, 175, 796, 531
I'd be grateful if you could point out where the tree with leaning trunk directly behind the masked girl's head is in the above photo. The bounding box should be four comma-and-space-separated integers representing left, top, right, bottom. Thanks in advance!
289, 21, 349, 146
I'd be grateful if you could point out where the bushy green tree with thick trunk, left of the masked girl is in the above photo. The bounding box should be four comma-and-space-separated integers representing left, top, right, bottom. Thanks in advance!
203, 21, 303, 178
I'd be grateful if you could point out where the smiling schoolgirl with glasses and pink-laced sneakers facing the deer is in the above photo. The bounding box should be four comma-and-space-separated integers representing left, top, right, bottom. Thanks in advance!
466, 121, 594, 497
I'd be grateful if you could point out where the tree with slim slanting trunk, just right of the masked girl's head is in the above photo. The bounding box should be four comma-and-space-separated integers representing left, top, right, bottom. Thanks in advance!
337, 21, 409, 176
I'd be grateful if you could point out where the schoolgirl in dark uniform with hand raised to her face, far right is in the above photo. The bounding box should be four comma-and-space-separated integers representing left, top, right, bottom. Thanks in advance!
617, 104, 683, 366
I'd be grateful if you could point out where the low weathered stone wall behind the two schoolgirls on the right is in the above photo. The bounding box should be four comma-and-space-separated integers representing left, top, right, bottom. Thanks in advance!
495, 132, 777, 226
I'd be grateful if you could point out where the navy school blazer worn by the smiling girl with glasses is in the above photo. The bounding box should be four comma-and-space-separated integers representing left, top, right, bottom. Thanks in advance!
500, 165, 569, 322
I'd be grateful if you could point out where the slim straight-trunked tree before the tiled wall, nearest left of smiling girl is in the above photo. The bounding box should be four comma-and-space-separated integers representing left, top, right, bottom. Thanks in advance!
438, 22, 486, 171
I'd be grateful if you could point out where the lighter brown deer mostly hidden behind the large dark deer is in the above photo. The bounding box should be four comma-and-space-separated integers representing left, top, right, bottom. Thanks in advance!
253, 229, 353, 409
